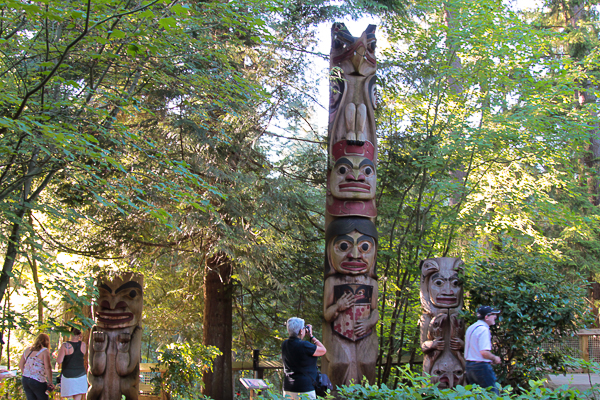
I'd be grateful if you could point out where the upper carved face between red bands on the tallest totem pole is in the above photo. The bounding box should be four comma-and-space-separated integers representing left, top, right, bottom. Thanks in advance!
329, 156, 377, 200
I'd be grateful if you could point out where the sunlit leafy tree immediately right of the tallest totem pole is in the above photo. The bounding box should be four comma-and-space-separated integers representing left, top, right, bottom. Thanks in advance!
378, 1, 596, 384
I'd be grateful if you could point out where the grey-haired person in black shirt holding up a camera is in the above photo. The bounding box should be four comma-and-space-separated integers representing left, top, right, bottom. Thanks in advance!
281, 317, 327, 400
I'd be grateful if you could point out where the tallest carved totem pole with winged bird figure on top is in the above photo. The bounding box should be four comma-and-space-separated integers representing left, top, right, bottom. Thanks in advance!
322, 23, 379, 387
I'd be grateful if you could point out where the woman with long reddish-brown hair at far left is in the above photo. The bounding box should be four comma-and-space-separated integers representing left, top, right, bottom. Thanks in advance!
19, 333, 54, 400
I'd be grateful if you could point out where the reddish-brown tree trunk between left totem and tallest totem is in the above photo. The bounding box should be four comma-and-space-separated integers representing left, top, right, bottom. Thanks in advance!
202, 252, 233, 400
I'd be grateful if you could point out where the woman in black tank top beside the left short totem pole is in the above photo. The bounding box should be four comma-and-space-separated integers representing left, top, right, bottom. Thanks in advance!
56, 328, 87, 400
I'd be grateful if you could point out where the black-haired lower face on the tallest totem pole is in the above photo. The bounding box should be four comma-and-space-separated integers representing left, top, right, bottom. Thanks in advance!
328, 230, 377, 275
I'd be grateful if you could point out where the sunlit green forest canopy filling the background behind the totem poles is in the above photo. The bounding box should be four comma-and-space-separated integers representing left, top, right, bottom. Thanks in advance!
0, 0, 600, 396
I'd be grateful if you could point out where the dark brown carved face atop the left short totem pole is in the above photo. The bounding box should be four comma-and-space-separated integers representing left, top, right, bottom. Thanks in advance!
93, 274, 144, 329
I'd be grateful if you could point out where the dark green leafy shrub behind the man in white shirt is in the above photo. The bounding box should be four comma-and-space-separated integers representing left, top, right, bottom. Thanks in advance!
465, 251, 590, 388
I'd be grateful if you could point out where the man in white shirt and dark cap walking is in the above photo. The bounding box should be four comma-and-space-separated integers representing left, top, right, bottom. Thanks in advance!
465, 306, 501, 395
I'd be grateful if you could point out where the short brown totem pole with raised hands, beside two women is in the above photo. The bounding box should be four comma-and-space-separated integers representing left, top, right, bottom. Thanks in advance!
87, 273, 144, 400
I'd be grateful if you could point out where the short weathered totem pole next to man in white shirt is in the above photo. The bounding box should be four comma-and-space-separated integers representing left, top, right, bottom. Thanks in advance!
420, 257, 465, 388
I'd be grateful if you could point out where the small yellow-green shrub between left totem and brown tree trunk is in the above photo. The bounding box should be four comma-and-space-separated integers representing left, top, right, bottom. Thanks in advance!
152, 343, 222, 400
